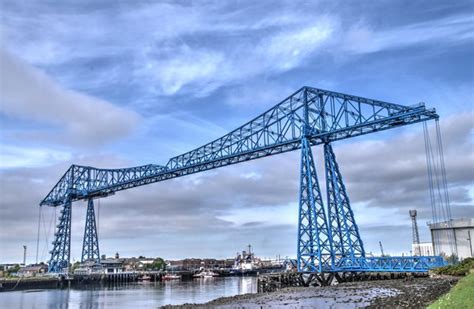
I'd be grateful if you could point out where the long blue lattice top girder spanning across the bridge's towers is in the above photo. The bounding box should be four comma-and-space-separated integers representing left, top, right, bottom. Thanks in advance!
41, 87, 438, 206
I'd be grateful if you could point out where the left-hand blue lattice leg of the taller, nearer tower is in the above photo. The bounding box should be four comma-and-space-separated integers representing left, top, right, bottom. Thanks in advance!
297, 137, 332, 272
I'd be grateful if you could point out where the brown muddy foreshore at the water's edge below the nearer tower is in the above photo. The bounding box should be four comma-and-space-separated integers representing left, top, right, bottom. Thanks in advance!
161, 277, 458, 309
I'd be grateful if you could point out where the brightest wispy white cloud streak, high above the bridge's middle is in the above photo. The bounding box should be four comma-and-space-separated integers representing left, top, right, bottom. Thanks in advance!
136, 17, 335, 96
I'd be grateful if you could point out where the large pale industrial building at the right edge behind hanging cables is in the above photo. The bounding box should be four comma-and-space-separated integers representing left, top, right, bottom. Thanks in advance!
428, 218, 474, 260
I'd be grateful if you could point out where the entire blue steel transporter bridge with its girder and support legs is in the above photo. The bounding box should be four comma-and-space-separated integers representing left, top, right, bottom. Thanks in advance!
40, 87, 443, 280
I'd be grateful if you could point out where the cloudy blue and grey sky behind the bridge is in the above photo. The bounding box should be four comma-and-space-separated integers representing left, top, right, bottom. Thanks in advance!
0, 0, 474, 263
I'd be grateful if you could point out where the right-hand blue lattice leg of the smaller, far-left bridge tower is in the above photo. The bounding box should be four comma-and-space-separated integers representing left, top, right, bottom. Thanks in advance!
81, 198, 100, 263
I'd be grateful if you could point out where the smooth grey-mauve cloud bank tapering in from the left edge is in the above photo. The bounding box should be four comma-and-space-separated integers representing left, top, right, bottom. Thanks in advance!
0, 49, 139, 145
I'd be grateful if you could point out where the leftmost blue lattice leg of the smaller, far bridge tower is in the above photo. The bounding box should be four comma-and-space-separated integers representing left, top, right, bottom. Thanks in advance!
48, 200, 72, 273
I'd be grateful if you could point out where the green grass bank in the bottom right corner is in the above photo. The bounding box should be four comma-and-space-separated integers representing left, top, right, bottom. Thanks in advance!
428, 273, 474, 309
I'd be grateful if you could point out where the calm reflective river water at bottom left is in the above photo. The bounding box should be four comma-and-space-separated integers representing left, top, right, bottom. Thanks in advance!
0, 277, 257, 309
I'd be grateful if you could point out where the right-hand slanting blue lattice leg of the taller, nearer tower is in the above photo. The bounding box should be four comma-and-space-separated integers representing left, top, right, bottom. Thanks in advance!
324, 143, 365, 262
